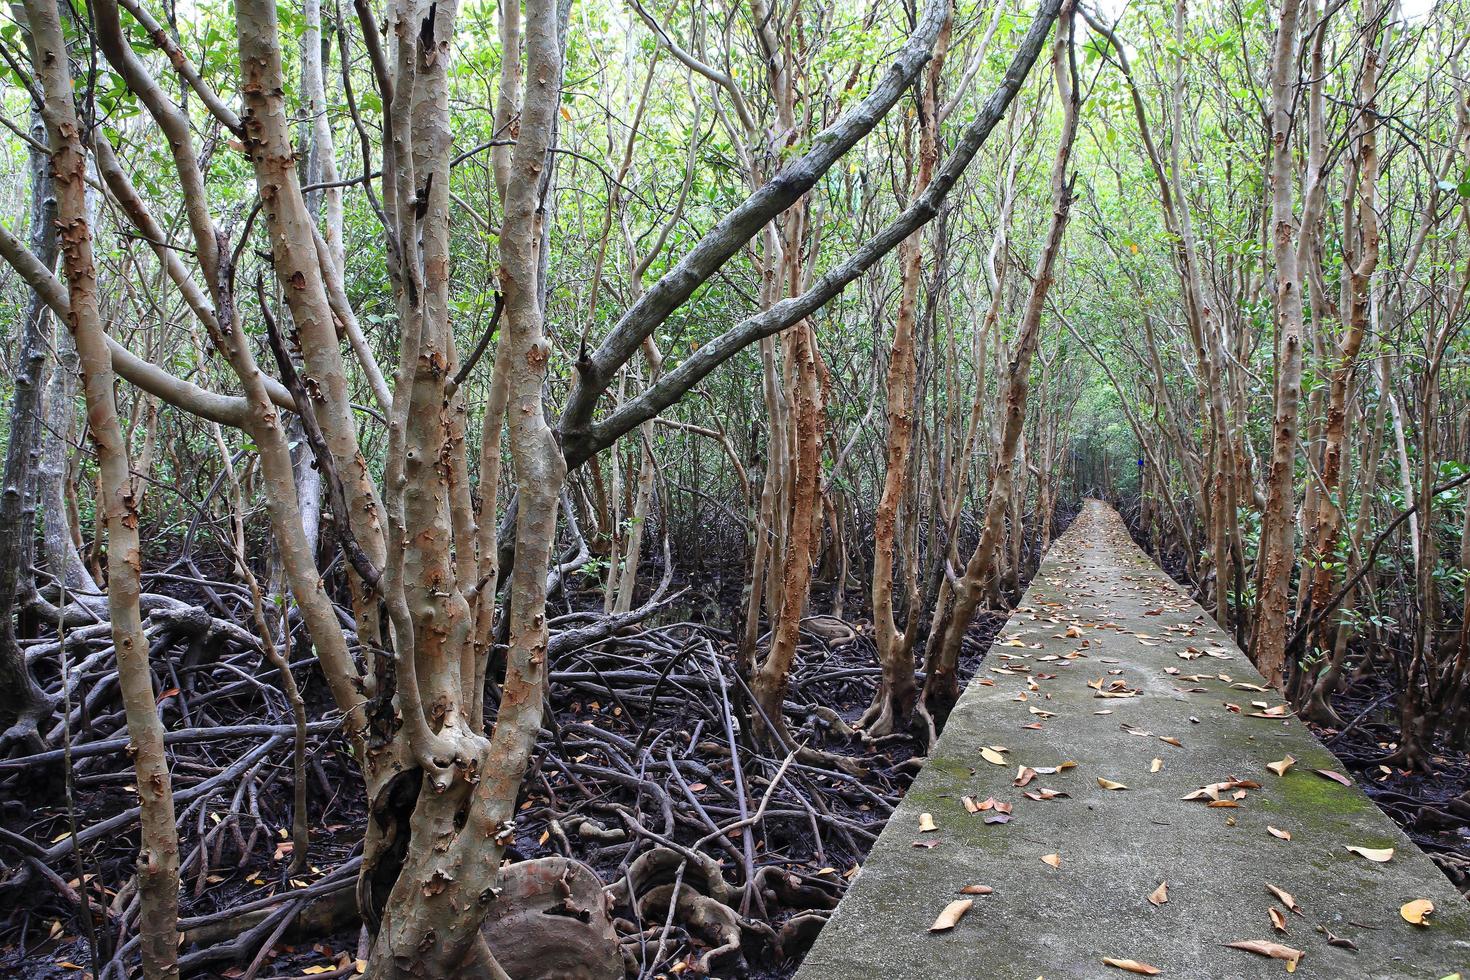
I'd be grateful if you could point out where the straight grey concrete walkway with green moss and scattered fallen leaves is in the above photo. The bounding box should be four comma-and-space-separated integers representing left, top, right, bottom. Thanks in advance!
797, 501, 1470, 980
